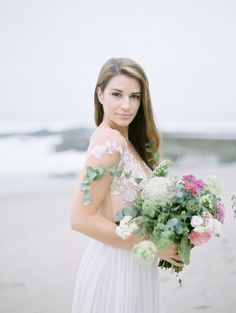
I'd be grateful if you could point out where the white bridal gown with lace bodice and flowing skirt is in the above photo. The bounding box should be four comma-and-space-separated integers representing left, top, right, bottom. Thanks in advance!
72, 128, 164, 313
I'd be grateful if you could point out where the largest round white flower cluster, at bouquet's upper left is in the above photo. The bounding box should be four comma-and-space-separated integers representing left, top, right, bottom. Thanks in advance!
141, 177, 173, 206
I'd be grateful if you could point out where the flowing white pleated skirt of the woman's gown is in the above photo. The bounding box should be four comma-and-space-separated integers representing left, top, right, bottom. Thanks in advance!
72, 239, 164, 313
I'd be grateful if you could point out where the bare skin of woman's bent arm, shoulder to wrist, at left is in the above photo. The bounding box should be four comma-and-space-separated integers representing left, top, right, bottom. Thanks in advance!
71, 130, 140, 250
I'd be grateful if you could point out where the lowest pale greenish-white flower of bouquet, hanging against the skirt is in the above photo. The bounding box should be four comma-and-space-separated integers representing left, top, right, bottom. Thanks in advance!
132, 240, 157, 264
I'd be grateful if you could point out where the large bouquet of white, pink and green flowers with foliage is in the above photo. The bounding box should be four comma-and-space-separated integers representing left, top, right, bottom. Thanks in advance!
116, 160, 225, 273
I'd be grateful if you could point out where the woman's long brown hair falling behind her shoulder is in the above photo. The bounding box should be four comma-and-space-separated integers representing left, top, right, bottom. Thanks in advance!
94, 58, 161, 169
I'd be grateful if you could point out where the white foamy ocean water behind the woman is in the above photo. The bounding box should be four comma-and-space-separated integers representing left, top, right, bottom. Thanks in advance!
0, 119, 236, 196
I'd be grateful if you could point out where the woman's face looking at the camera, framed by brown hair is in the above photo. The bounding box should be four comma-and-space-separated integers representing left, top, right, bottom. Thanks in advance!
97, 75, 141, 128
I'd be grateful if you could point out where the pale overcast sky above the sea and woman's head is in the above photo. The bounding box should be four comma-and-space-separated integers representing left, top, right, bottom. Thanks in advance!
0, 0, 236, 125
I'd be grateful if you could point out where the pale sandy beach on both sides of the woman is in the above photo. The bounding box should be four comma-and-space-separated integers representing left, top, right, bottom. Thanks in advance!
0, 163, 236, 313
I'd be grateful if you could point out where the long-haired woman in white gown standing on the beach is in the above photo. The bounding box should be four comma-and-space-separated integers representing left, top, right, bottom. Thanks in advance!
71, 58, 180, 313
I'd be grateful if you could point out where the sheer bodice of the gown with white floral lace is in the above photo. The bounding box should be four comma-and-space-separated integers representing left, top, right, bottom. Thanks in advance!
83, 128, 151, 221
